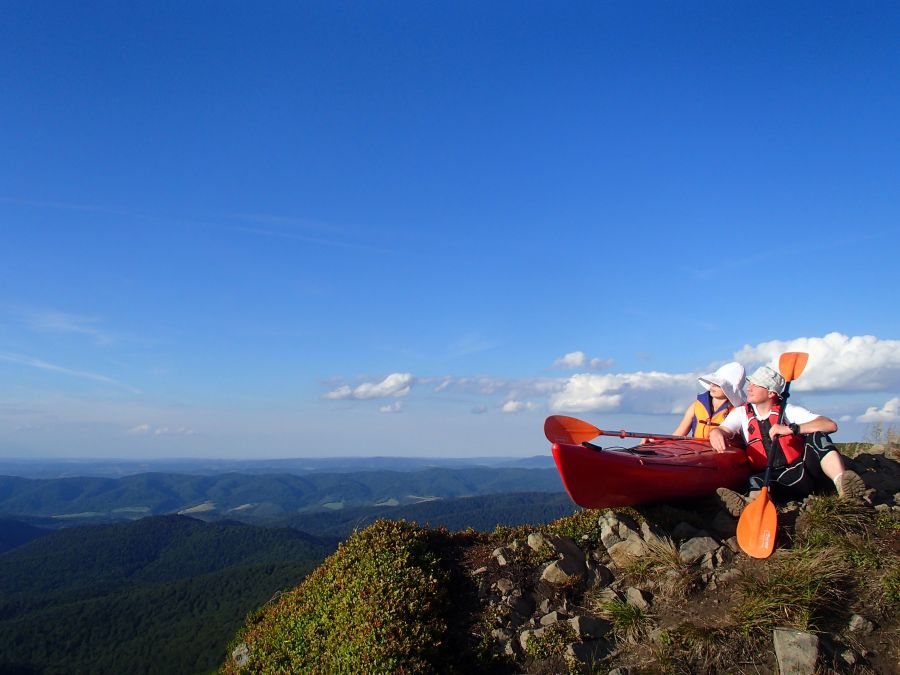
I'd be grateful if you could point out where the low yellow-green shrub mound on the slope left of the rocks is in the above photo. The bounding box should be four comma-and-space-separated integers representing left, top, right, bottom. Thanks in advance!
224, 520, 447, 673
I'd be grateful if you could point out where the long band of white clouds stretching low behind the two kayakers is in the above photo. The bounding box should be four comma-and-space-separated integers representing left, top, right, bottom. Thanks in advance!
323, 332, 900, 423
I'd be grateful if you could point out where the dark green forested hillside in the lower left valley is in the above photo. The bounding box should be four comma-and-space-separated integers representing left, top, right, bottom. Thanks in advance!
0, 516, 333, 674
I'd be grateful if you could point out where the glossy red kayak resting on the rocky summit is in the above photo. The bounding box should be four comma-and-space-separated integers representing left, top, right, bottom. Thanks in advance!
553, 439, 751, 509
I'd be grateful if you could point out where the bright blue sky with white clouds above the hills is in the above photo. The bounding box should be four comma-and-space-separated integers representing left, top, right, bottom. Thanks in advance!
0, 2, 900, 458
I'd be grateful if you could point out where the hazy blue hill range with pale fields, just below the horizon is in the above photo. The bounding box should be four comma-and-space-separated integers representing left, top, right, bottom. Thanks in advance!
0, 467, 563, 525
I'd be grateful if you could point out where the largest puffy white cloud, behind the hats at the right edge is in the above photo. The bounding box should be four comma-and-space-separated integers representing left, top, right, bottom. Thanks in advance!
734, 333, 900, 391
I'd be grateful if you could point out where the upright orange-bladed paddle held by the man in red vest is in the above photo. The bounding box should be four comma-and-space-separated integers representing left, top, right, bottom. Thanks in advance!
737, 352, 809, 558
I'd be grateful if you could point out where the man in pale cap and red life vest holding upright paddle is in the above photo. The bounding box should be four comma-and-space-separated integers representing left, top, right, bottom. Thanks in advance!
709, 366, 866, 517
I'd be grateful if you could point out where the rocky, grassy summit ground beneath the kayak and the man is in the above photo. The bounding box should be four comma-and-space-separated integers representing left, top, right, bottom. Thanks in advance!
459, 446, 900, 675
